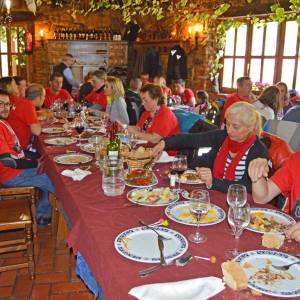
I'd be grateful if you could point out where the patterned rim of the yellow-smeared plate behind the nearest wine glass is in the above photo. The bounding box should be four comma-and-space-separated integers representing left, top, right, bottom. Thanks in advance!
165, 201, 226, 226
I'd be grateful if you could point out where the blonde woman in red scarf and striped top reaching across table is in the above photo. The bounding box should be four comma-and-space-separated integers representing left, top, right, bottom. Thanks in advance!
153, 102, 268, 192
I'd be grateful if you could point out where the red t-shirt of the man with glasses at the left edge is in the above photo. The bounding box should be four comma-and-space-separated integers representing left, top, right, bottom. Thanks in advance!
0, 120, 22, 183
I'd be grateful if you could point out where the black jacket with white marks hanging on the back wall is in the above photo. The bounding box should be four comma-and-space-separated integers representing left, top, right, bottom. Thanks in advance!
167, 45, 187, 84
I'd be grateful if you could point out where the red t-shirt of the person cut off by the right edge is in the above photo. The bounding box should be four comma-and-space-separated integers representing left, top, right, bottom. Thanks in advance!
271, 151, 300, 213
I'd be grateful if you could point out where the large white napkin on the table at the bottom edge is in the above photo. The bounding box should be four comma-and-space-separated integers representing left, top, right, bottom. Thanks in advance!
129, 277, 224, 300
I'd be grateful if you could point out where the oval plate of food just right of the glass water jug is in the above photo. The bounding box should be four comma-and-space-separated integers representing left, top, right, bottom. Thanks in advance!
127, 187, 179, 206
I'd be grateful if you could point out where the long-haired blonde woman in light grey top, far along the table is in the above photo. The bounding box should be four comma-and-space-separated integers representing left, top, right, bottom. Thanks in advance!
104, 76, 129, 124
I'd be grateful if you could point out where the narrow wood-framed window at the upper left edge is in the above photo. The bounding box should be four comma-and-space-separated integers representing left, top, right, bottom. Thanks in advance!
0, 26, 26, 78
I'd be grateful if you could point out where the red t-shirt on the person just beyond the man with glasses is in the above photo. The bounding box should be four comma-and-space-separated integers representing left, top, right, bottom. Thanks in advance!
7, 96, 39, 150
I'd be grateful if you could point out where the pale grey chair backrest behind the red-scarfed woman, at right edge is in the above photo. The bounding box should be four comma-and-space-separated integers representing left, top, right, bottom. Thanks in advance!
264, 120, 300, 151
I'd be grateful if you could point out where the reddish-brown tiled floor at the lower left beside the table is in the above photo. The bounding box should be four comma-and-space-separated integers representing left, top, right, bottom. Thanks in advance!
0, 226, 93, 300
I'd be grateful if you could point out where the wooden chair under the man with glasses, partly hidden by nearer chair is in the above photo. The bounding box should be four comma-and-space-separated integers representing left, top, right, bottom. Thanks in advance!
0, 186, 37, 237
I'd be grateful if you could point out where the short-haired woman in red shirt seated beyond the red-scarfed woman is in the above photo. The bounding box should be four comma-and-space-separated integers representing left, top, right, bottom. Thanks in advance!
128, 84, 180, 143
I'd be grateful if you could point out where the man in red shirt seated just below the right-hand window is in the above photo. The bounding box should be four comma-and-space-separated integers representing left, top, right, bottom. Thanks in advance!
220, 77, 256, 127
